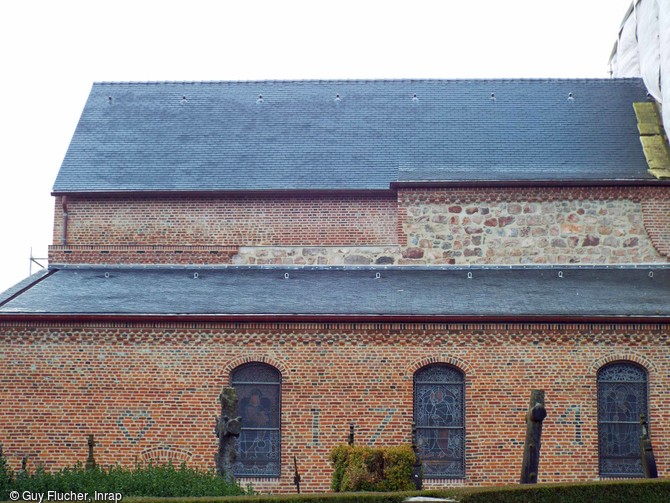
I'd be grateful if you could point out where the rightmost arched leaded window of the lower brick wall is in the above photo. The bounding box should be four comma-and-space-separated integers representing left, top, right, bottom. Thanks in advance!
598, 362, 649, 477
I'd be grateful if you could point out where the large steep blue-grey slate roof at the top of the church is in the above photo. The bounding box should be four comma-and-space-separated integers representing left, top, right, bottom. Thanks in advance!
53, 79, 653, 193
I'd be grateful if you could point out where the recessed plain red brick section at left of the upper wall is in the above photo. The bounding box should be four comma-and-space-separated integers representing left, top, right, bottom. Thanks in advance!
54, 192, 397, 246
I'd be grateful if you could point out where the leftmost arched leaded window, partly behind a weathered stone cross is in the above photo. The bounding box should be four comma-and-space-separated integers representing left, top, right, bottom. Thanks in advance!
231, 363, 281, 477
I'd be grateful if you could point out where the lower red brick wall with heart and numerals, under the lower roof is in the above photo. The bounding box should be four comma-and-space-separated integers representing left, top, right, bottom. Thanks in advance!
0, 321, 670, 492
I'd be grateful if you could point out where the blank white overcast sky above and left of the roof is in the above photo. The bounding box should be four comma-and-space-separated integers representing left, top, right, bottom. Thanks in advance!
0, 0, 631, 291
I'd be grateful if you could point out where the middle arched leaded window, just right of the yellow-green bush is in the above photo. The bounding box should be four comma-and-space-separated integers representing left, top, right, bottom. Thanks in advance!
414, 364, 465, 478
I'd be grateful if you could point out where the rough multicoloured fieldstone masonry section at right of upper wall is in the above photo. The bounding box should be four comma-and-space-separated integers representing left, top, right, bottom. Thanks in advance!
399, 188, 668, 265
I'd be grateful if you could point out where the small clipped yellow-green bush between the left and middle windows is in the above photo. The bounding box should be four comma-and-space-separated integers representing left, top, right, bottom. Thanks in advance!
330, 445, 414, 492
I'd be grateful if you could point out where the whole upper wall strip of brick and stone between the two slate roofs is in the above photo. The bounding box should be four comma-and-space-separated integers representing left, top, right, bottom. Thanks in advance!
50, 187, 670, 265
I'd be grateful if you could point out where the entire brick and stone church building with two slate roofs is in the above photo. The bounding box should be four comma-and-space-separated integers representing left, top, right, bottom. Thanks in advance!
0, 78, 670, 492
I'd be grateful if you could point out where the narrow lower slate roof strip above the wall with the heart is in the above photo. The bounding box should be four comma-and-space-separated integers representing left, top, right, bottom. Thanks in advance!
0, 266, 670, 320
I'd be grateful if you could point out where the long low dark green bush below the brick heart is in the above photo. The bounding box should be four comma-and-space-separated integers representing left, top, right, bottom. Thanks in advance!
0, 464, 245, 501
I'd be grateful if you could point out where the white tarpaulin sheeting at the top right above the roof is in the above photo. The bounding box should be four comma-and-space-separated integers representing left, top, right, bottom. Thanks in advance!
610, 0, 670, 128
